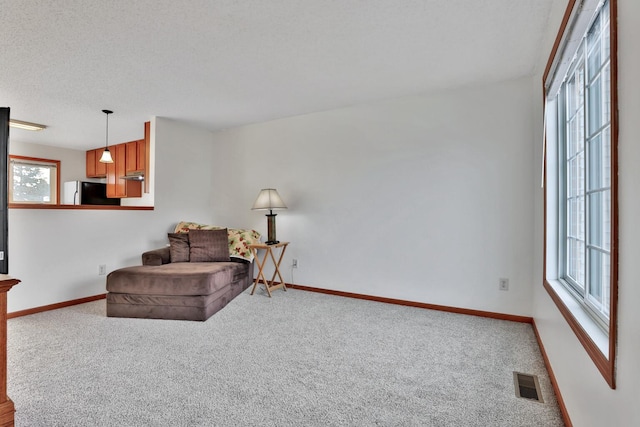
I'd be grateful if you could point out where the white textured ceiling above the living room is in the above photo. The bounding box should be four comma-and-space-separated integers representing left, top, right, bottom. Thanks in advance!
0, 0, 561, 149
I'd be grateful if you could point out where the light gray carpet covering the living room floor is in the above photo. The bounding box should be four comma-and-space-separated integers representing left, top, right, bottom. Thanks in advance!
8, 290, 562, 427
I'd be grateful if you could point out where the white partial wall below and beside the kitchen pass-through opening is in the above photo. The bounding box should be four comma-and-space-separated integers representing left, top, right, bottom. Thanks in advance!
8, 118, 214, 312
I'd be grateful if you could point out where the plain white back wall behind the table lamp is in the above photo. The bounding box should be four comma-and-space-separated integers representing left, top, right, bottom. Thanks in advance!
212, 78, 533, 315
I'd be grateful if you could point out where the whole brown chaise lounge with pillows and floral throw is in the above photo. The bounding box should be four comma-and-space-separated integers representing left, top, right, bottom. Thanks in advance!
107, 223, 259, 321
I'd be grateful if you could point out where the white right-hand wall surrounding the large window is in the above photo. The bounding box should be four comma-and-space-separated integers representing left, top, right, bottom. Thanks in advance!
534, 0, 640, 427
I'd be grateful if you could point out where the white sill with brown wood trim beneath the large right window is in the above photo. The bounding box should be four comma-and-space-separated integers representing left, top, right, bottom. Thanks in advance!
544, 280, 615, 388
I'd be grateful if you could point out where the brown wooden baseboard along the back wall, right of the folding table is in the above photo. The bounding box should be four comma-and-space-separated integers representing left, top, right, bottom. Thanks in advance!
287, 283, 533, 323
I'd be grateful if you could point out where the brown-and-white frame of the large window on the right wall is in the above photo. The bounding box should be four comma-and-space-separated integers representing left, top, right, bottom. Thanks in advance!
542, 0, 619, 389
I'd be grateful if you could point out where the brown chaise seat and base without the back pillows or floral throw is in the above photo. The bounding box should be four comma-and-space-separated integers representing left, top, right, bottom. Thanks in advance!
107, 247, 253, 321
